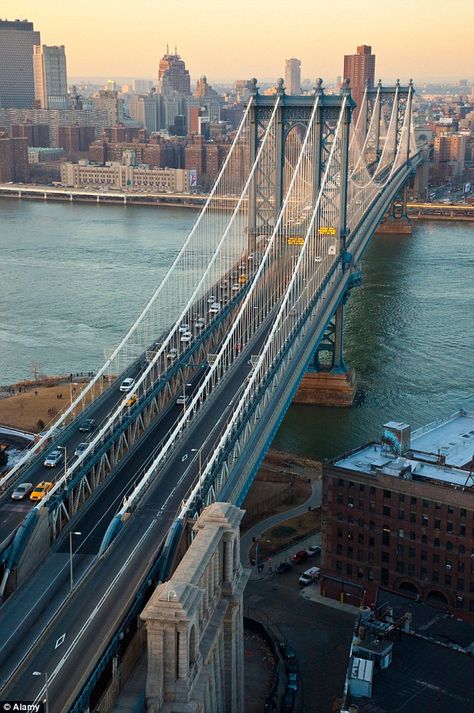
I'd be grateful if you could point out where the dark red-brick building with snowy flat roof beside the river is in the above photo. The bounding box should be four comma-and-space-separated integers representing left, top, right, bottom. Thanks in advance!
322, 411, 474, 621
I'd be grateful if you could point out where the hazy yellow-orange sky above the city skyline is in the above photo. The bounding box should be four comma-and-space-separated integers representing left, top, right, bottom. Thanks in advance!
4, 0, 474, 83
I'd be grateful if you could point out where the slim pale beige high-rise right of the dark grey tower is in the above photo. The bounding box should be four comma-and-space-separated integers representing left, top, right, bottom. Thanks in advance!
33, 45, 68, 109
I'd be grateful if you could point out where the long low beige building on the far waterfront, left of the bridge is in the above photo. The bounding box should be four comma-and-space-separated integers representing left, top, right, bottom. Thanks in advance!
61, 154, 190, 193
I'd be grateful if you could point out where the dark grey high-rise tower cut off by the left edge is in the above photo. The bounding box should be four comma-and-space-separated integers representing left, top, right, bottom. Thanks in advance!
0, 20, 41, 109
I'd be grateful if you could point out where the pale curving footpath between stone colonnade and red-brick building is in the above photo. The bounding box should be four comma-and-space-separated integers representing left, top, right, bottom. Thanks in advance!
240, 480, 321, 579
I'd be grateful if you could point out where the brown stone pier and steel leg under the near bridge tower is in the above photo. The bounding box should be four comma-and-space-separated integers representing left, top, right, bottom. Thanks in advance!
293, 302, 357, 407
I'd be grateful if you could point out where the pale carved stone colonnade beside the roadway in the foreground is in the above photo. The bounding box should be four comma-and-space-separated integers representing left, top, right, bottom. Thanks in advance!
141, 503, 249, 713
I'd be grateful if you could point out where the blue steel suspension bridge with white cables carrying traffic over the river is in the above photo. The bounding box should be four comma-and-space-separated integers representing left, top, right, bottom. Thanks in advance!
0, 80, 422, 711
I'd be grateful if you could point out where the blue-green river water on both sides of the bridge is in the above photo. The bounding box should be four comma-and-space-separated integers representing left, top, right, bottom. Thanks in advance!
0, 200, 474, 458
